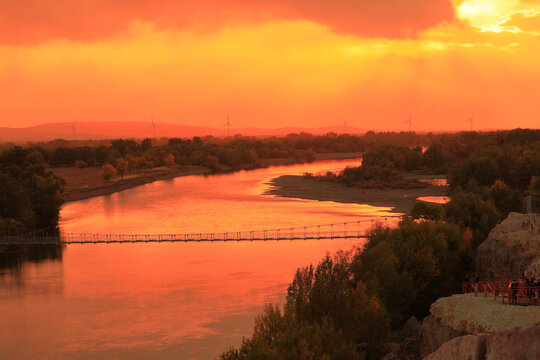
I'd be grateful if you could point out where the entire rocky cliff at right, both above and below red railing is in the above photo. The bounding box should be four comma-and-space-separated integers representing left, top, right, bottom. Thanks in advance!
385, 213, 540, 360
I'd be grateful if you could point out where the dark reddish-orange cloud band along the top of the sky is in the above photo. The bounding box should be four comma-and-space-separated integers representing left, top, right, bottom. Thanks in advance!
0, 0, 454, 44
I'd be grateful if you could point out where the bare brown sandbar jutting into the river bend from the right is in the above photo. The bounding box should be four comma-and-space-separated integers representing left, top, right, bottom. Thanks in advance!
267, 175, 448, 213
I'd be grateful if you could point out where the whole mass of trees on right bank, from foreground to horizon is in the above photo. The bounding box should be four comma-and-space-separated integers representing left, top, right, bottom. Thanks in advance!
220, 130, 540, 360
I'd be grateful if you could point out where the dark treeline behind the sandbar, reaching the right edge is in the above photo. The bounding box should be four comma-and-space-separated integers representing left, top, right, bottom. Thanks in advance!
312, 129, 540, 192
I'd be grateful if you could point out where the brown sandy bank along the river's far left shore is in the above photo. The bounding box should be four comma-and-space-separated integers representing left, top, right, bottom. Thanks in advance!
50, 166, 210, 202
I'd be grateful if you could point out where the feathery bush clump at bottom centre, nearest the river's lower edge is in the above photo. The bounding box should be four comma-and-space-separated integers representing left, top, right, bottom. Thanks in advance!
220, 252, 390, 360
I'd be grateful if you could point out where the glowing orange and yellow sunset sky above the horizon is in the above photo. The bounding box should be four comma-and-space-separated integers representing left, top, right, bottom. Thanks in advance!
0, 0, 540, 130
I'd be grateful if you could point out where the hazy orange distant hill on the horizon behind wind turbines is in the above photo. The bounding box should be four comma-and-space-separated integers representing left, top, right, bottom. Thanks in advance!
0, 121, 367, 143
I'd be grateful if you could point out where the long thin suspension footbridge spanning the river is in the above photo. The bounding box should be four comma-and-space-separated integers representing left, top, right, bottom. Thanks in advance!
0, 217, 397, 245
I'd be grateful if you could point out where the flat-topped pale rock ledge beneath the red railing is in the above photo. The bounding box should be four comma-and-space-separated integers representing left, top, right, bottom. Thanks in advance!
422, 294, 540, 360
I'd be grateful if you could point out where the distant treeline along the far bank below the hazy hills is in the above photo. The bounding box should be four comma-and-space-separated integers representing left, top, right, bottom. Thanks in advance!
3, 132, 435, 171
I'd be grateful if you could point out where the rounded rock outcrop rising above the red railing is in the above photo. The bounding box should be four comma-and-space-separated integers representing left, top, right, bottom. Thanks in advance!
476, 213, 540, 279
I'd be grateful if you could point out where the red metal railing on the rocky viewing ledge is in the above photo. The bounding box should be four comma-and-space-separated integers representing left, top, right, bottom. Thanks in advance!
463, 280, 540, 305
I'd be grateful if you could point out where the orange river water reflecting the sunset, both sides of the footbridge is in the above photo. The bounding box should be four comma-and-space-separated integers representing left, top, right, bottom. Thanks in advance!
0, 160, 396, 360
